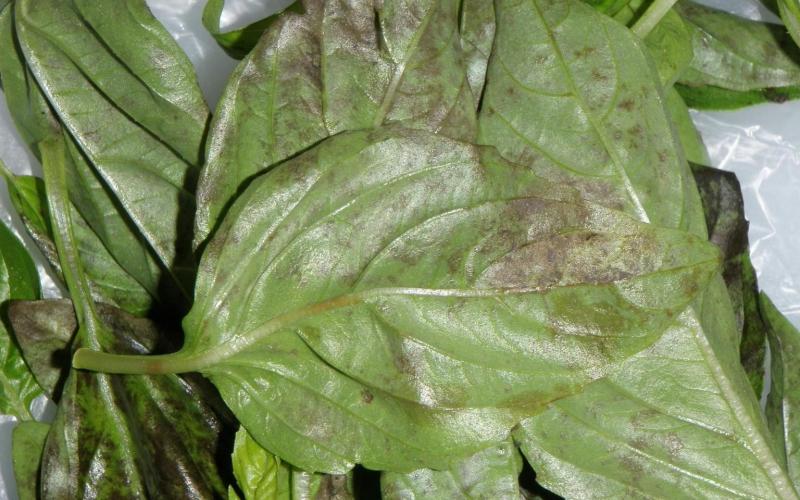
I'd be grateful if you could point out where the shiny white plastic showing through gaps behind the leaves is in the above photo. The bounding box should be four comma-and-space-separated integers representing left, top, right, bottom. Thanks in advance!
0, 0, 800, 500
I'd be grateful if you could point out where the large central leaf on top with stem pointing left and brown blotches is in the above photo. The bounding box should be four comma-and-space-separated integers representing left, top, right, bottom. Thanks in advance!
75, 129, 719, 473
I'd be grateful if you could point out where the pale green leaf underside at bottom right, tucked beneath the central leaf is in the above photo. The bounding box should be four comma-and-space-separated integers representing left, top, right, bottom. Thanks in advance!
515, 284, 798, 499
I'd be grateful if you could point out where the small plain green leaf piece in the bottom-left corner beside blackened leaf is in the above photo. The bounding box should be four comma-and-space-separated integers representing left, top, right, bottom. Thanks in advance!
11, 421, 50, 500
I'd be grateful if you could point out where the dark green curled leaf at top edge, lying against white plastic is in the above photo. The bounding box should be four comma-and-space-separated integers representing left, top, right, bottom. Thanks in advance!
203, 0, 303, 59
